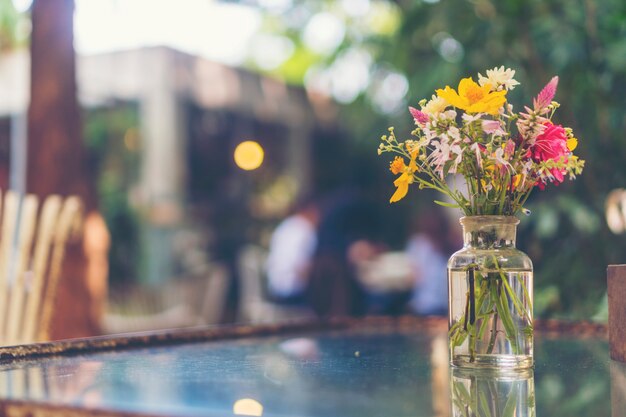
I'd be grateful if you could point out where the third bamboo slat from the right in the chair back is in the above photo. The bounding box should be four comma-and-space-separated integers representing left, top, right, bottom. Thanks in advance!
5, 194, 39, 344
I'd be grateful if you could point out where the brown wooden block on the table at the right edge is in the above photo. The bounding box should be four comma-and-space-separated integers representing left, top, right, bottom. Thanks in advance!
607, 265, 626, 362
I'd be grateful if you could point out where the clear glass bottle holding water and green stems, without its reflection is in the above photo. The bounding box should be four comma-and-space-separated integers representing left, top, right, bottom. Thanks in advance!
448, 216, 533, 369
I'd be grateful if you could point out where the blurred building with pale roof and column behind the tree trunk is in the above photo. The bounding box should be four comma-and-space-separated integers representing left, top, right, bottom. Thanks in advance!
0, 47, 336, 284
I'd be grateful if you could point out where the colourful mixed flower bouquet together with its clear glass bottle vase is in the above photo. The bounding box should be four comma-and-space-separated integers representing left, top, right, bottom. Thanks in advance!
378, 67, 584, 368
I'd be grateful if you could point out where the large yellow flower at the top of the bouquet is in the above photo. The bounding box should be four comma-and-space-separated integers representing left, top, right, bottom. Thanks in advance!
436, 77, 506, 115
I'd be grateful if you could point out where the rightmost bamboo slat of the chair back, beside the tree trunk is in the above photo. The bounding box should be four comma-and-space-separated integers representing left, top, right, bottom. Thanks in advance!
38, 196, 82, 341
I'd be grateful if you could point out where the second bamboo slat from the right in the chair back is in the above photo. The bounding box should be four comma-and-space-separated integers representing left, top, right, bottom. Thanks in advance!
22, 195, 62, 343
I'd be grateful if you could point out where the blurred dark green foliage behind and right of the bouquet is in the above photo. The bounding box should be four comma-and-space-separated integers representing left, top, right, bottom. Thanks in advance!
254, 0, 626, 318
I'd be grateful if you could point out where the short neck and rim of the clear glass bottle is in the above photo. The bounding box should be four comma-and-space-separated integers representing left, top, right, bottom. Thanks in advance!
460, 216, 519, 249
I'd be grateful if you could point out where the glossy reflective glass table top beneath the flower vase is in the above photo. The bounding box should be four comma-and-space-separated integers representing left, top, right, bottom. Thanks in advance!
0, 326, 626, 417
